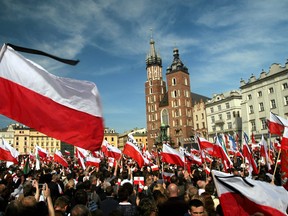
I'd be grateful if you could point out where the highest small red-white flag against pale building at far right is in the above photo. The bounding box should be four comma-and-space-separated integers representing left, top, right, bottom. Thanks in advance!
267, 112, 288, 136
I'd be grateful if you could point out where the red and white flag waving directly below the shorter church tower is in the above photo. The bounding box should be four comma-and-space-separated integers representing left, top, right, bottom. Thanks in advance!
161, 144, 185, 167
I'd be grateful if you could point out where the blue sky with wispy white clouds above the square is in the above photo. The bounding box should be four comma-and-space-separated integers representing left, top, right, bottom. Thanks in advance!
0, 0, 288, 133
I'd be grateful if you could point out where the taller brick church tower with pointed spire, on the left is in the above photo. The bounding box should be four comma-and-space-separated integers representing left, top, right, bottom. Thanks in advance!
145, 38, 166, 149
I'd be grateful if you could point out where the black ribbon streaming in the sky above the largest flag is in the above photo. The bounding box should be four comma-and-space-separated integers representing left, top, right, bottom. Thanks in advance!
7, 43, 79, 65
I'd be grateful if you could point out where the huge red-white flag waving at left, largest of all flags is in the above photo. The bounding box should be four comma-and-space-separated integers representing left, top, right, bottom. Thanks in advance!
0, 44, 104, 151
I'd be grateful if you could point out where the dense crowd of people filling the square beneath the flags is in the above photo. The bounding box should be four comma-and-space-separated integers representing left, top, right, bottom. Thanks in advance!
0, 151, 281, 216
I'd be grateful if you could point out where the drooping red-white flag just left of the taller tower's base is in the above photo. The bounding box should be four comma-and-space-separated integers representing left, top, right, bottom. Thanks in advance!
122, 134, 145, 168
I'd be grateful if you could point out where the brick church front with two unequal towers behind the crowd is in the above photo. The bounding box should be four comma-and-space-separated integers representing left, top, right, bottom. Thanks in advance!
145, 39, 194, 149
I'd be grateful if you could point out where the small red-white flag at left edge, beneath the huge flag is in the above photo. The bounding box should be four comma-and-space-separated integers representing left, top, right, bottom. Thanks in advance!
0, 137, 19, 164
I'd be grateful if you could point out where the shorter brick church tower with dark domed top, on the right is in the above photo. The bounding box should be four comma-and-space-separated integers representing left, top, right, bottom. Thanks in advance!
166, 48, 194, 147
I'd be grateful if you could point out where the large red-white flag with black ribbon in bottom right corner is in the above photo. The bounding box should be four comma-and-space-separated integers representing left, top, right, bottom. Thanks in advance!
212, 170, 288, 216
